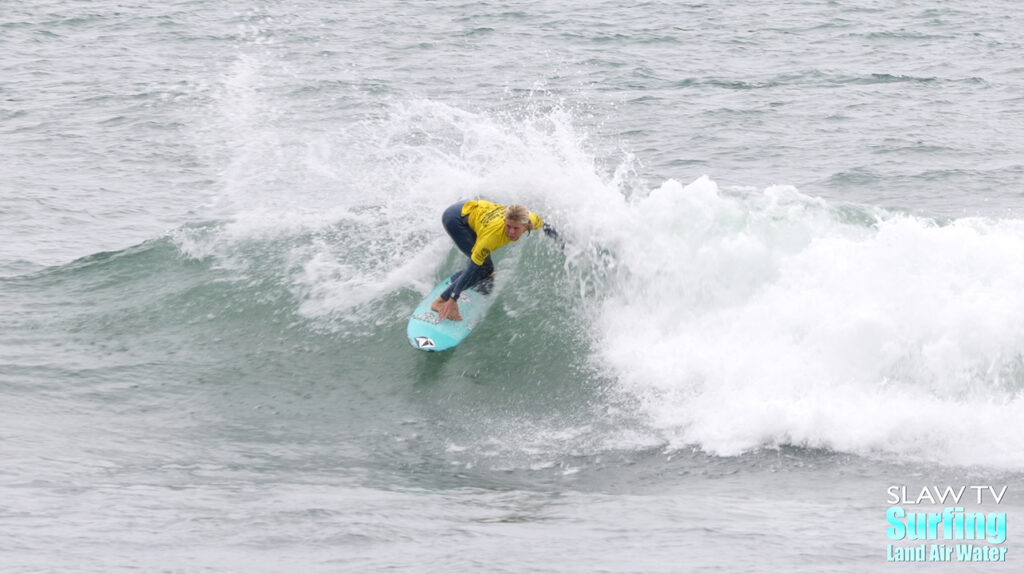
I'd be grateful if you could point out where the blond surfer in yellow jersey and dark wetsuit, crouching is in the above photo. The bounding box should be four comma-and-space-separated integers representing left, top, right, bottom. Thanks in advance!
430, 200, 558, 321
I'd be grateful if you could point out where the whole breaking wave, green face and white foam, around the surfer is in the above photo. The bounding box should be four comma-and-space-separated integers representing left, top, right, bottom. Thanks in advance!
8, 95, 1024, 469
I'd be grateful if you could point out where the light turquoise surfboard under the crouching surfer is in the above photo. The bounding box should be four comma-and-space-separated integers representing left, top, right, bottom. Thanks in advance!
406, 275, 495, 351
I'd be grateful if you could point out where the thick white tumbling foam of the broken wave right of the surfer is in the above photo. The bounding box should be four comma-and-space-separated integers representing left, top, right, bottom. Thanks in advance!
596, 178, 1024, 467
